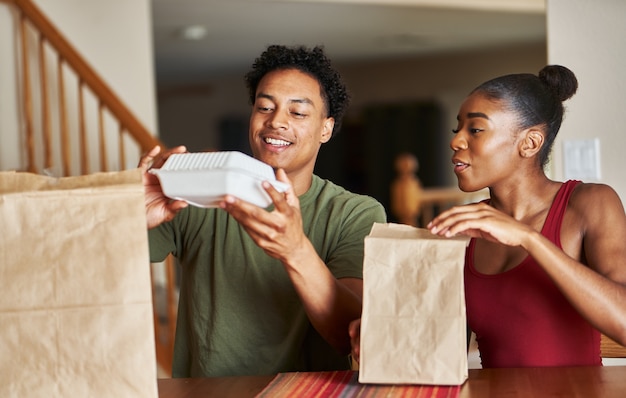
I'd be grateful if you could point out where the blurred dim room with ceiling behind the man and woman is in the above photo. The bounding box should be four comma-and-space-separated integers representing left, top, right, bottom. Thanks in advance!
152, 0, 547, 218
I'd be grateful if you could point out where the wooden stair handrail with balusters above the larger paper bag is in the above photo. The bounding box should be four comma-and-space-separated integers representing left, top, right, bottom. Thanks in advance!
0, 0, 162, 175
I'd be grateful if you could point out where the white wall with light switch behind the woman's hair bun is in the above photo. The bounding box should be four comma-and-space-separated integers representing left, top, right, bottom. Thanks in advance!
547, 0, 626, 202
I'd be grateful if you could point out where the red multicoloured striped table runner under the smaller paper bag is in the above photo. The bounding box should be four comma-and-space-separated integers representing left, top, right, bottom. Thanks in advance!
257, 370, 461, 398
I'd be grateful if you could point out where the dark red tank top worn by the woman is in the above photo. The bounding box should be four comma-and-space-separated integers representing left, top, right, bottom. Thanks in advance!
464, 181, 602, 368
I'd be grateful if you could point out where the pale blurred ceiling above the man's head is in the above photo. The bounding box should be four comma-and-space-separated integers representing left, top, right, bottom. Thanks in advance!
152, 0, 546, 87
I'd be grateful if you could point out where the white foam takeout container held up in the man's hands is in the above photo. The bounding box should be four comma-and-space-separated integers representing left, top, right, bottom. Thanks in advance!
150, 151, 288, 208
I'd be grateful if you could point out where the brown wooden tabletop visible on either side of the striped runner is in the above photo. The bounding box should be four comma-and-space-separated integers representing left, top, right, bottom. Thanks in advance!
158, 366, 626, 398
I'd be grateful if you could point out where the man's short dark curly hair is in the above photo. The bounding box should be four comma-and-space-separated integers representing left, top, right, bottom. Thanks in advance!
244, 45, 350, 132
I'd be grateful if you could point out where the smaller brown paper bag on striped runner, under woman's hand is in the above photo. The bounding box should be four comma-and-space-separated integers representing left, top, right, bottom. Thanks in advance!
359, 224, 468, 385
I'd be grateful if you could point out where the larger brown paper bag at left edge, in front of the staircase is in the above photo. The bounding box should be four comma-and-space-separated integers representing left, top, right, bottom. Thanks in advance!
0, 169, 157, 398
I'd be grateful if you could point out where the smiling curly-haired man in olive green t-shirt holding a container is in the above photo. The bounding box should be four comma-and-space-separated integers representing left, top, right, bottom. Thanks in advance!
141, 45, 386, 377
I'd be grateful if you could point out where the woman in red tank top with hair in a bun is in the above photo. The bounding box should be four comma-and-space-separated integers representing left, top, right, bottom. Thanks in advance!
351, 65, 626, 368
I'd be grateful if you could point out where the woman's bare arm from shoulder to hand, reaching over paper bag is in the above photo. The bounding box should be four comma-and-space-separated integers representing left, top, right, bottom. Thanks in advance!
429, 184, 626, 345
